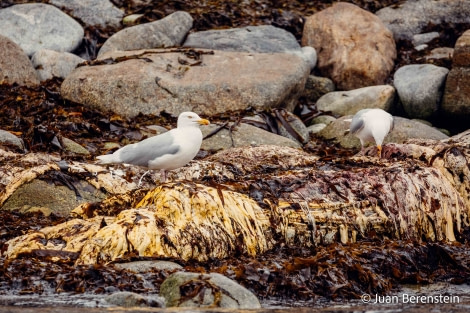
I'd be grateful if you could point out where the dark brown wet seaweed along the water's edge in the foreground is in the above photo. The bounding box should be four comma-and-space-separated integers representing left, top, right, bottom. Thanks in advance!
0, 211, 470, 304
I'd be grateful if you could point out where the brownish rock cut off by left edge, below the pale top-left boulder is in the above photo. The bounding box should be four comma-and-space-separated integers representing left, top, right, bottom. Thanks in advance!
0, 35, 39, 86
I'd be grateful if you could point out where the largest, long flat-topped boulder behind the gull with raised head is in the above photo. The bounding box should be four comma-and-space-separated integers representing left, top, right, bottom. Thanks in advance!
61, 49, 310, 117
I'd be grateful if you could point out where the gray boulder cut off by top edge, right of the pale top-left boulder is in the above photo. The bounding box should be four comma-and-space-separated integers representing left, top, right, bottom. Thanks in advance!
49, 0, 124, 27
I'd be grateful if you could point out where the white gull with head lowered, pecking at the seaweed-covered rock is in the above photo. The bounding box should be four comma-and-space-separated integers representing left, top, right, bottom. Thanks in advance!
349, 109, 393, 158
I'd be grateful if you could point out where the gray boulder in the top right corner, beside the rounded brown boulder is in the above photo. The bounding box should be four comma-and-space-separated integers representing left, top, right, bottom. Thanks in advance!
375, 0, 470, 40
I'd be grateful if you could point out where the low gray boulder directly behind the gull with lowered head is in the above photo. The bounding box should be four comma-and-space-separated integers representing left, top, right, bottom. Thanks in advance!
317, 115, 448, 149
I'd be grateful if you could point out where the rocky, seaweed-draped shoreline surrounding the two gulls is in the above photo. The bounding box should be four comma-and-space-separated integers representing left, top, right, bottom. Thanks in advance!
0, 0, 470, 308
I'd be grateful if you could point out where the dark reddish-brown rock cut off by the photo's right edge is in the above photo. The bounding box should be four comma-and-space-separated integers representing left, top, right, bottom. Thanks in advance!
442, 30, 470, 119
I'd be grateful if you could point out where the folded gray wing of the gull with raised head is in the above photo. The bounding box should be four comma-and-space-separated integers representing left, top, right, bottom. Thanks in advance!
119, 132, 180, 167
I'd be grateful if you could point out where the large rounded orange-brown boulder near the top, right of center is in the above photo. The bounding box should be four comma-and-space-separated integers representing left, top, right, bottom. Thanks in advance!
302, 2, 397, 90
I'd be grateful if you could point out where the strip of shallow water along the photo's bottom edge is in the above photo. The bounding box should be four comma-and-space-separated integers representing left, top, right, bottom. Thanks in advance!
0, 283, 470, 313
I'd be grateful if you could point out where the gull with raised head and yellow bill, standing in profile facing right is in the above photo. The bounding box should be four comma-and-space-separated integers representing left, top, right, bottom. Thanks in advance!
97, 112, 209, 185
